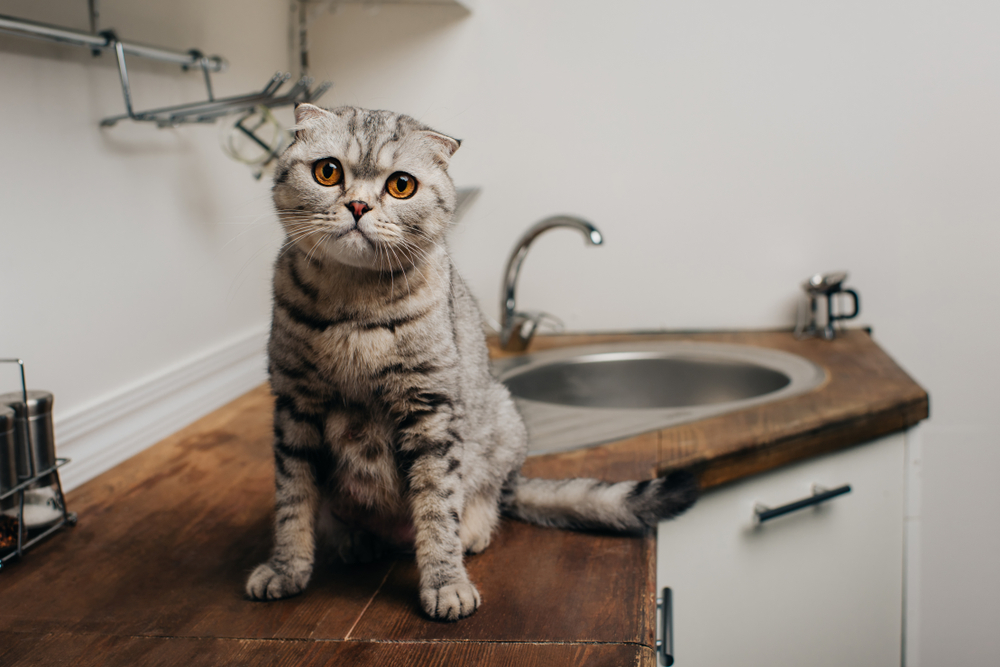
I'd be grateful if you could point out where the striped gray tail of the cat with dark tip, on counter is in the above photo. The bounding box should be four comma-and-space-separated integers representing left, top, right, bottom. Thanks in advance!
501, 470, 698, 532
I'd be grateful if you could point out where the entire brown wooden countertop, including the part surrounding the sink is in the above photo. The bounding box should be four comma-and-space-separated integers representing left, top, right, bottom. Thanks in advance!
0, 331, 928, 667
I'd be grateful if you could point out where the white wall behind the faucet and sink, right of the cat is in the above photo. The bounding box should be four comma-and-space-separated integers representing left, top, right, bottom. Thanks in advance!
310, 0, 1000, 665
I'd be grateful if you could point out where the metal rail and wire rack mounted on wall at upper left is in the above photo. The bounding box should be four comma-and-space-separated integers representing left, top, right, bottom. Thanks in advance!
0, 9, 330, 129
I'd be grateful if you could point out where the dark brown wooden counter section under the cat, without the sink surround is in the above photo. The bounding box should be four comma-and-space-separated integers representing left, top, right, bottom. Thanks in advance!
0, 387, 655, 665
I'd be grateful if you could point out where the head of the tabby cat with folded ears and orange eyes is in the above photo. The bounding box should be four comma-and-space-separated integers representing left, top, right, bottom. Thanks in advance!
273, 104, 459, 271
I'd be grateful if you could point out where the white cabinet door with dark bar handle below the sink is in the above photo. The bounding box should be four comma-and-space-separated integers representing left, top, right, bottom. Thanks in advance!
657, 433, 905, 667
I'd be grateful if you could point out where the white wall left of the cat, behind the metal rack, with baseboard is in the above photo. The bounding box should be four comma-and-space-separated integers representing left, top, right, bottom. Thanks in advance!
0, 0, 289, 486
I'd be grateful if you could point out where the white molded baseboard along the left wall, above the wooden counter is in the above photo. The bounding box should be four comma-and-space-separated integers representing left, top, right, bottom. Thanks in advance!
55, 328, 267, 490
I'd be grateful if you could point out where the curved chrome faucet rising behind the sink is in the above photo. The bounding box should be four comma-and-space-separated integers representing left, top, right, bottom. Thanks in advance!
500, 215, 604, 352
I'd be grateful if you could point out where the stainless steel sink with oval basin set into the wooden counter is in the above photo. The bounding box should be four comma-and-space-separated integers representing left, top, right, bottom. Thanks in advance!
493, 341, 826, 453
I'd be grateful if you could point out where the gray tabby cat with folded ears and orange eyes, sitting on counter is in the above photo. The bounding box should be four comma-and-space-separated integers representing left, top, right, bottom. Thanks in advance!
246, 104, 697, 620
